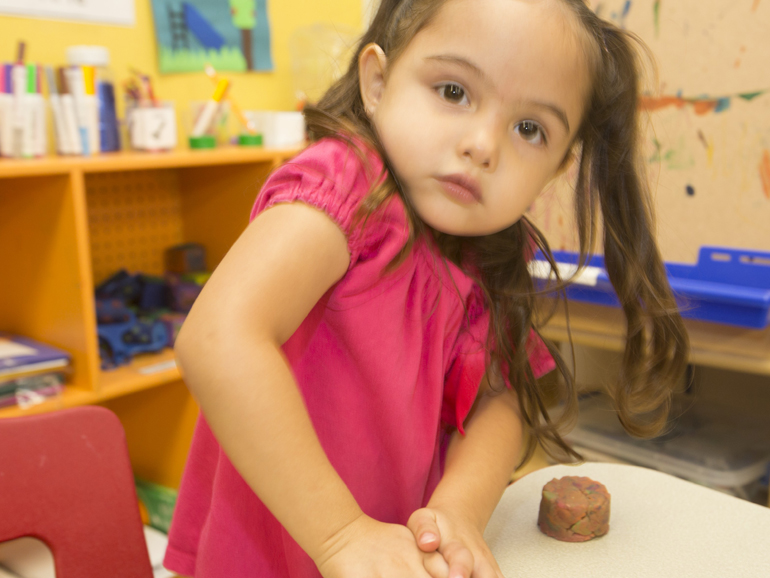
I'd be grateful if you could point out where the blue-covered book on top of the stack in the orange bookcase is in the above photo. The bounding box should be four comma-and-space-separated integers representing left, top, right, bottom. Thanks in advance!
0, 332, 71, 382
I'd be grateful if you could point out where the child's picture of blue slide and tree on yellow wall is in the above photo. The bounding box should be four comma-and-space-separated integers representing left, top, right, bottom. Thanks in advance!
148, 0, 273, 73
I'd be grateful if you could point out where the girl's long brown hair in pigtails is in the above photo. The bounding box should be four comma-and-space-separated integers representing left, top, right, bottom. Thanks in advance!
305, 0, 688, 459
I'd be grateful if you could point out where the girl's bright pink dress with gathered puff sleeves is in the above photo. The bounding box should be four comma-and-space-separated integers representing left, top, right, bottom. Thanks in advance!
165, 139, 553, 578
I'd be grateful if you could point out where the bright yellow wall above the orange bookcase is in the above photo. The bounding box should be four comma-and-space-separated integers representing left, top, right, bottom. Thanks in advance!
0, 0, 361, 132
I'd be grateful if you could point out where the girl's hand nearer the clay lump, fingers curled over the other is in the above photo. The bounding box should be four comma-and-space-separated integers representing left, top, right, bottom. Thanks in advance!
407, 508, 504, 578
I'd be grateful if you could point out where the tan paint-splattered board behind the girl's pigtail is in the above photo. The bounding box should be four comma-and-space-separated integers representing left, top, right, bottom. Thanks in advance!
532, 0, 770, 262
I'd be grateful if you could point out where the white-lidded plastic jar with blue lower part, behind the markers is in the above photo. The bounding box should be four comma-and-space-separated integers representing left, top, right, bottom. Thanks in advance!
67, 46, 120, 152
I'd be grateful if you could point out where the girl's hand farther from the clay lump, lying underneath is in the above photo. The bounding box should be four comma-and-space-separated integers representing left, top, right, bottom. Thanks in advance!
313, 515, 449, 578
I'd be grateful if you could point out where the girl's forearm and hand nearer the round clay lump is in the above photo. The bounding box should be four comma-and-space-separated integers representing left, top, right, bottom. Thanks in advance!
408, 378, 522, 578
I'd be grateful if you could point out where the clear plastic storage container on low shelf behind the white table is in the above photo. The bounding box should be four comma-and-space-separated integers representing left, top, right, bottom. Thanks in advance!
567, 395, 770, 499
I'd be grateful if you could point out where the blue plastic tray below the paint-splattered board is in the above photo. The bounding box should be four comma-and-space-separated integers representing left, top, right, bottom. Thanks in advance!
532, 247, 770, 329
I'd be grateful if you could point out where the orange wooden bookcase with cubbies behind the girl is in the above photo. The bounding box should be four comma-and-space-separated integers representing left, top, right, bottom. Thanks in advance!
0, 149, 297, 487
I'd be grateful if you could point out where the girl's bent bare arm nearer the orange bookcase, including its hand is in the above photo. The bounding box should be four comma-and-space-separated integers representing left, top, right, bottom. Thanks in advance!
175, 203, 439, 577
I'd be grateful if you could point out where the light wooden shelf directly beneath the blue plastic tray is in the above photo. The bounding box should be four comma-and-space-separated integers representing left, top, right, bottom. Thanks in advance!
543, 301, 770, 375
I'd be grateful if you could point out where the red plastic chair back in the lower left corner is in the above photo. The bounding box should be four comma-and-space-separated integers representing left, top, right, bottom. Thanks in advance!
0, 406, 153, 578
